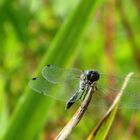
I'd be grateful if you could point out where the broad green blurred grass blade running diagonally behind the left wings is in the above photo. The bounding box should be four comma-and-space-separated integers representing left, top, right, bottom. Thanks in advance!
3, 0, 101, 140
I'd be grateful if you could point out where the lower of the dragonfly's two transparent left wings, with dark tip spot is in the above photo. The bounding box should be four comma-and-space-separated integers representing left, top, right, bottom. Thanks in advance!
29, 76, 79, 102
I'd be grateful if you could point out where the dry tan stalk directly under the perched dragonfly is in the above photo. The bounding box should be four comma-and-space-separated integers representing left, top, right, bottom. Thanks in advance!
55, 87, 93, 140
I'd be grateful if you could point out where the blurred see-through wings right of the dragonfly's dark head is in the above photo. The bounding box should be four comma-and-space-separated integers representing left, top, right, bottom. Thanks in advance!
89, 74, 140, 109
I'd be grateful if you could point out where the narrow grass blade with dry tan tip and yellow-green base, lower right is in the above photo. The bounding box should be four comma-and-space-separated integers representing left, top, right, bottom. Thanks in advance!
88, 72, 133, 140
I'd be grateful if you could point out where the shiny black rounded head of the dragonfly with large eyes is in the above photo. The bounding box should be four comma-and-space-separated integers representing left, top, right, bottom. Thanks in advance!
86, 70, 100, 83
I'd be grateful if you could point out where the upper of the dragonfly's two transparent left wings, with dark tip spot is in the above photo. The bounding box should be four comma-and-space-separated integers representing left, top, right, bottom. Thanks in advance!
42, 65, 82, 83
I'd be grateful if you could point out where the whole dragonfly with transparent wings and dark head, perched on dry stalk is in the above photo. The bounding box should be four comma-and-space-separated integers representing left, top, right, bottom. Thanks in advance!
29, 65, 140, 109
